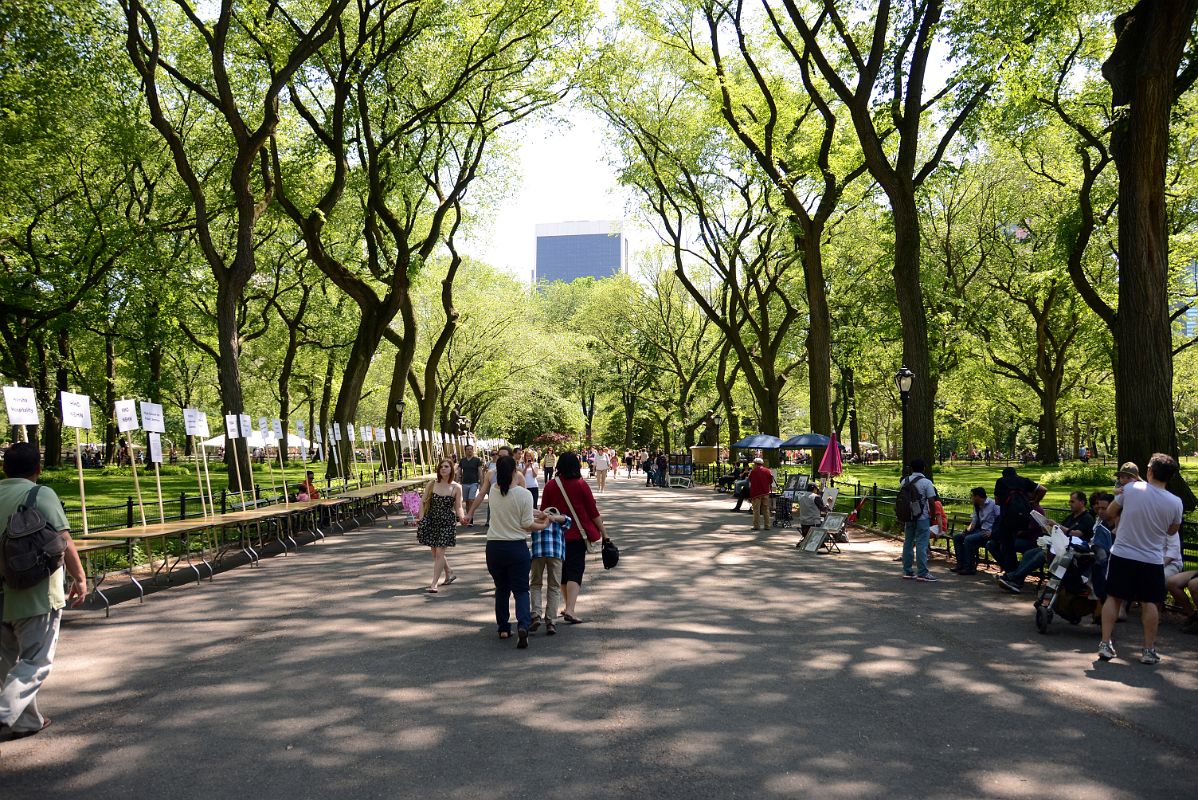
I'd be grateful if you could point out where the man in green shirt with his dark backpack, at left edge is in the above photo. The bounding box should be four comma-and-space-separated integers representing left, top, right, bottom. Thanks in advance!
0, 442, 87, 741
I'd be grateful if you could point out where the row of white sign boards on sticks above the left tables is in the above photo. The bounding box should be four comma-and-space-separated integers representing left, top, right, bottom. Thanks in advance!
4, 386, 445, 463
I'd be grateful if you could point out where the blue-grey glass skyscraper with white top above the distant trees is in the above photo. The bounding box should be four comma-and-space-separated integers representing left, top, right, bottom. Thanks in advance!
536, 220, 628, 283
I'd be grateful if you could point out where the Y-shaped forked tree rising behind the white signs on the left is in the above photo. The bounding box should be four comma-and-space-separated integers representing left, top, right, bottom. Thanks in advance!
121, 0, 349, 483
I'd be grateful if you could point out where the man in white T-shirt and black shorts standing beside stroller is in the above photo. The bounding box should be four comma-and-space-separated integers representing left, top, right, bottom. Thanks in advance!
1099, 453, 1182, 663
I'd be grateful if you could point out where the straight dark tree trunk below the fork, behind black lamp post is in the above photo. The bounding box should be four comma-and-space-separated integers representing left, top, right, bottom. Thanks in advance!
888, 191, 936, 469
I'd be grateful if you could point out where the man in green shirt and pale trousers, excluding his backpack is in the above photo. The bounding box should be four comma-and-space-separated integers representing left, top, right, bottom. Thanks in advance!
0, 442, 87, 741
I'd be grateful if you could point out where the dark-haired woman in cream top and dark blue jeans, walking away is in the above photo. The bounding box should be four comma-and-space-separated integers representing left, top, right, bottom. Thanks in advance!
486, 455, 549, 649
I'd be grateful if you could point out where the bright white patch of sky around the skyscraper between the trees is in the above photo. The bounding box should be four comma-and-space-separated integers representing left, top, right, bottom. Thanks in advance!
464, 107, 652, 283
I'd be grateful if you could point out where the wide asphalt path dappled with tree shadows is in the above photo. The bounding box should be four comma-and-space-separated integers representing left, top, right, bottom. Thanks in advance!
0, 477, 1198, 800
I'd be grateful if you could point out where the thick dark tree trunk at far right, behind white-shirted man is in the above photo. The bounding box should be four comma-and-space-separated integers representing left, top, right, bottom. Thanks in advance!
1102, 0, 1198, 508
